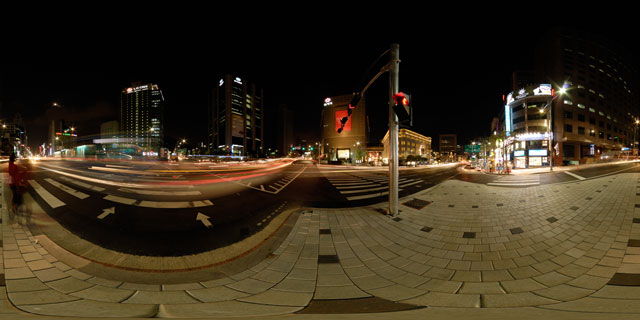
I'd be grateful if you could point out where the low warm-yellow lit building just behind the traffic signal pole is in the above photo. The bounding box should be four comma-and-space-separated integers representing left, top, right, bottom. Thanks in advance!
382, 129, 431, 163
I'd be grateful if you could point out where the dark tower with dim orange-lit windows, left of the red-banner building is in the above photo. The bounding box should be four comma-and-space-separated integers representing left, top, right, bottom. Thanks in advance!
208, 74, 265, 156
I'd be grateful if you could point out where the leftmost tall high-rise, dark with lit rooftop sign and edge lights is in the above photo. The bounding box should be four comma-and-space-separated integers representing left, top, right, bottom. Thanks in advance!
120, 83, 164, 156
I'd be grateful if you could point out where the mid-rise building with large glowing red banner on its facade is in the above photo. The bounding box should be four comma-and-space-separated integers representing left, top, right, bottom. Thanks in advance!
320, 94, 367, 163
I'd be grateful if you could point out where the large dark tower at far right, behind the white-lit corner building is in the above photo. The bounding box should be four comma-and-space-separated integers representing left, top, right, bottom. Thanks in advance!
536, 28, 640, 164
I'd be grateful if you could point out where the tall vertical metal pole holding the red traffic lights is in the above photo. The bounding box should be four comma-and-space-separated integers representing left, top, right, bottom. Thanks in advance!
389, 43, 400, 216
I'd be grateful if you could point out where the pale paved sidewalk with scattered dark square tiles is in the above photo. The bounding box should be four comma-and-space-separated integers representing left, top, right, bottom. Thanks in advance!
0, 173, 640, 319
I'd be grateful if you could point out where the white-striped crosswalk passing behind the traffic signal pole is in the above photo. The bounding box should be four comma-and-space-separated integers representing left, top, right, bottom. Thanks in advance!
326, 173, 423, 201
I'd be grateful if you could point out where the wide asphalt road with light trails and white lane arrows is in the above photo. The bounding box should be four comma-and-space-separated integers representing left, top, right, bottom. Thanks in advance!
21, 159, 458, 256
